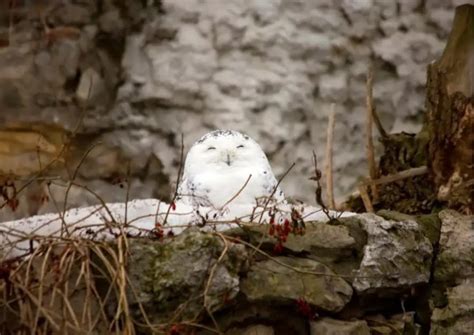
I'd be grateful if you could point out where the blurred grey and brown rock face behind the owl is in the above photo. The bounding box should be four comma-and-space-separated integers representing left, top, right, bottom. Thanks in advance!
0, 0, 462, 221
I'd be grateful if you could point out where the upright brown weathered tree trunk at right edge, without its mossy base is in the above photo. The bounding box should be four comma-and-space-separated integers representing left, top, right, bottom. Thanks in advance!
423, 5, 474, 213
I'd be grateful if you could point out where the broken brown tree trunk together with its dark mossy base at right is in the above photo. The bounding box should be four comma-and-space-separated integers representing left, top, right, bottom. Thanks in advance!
346, 5, 474, 214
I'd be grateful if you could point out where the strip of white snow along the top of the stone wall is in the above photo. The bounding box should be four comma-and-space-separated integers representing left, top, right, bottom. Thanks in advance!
0, 199, 354, 260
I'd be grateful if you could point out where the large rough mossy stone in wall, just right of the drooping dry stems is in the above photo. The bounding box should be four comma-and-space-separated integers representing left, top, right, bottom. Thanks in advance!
128, 230, 247, 322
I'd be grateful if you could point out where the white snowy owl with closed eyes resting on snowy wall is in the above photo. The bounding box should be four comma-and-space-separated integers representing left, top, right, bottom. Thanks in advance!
177, 130, 285, 208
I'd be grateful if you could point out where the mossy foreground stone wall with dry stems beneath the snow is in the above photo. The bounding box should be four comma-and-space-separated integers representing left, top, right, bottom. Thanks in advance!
0, 210, 474, 335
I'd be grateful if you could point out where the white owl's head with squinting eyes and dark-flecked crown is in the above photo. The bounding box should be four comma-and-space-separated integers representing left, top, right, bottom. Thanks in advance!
184, 130, 268, 173
